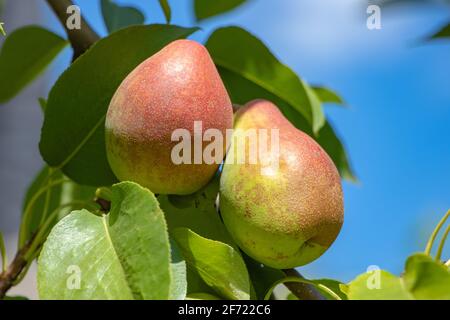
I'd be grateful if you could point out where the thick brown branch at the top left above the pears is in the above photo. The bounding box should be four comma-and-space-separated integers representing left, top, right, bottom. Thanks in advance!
47, 0, 100, 61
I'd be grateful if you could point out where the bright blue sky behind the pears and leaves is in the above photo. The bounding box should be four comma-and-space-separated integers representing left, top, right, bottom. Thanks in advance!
43, 0, 450, 281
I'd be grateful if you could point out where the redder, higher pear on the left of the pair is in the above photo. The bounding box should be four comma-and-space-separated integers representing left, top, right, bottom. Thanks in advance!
105, 40, 233, 195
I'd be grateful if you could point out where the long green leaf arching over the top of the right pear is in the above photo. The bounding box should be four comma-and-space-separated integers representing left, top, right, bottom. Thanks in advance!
206, 27, 356, 181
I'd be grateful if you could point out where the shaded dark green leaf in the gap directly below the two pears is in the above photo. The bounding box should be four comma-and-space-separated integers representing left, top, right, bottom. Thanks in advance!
158, 177, 237, 248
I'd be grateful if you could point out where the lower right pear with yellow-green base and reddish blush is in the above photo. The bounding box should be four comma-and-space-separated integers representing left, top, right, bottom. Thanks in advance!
220, 100, 344, 269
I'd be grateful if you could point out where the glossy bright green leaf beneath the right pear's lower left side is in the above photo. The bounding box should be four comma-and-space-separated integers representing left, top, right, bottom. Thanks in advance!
172, 228, 250, 300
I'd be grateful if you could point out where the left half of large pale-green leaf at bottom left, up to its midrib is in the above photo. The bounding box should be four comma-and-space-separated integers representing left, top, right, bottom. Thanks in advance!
38, 210, 133, 300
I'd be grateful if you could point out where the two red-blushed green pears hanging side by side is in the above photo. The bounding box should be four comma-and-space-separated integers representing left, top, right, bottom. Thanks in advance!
105, 40, 343, 269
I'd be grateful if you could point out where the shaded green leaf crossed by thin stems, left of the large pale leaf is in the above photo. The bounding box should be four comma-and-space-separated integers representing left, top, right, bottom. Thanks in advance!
20, 166, 95, 245
